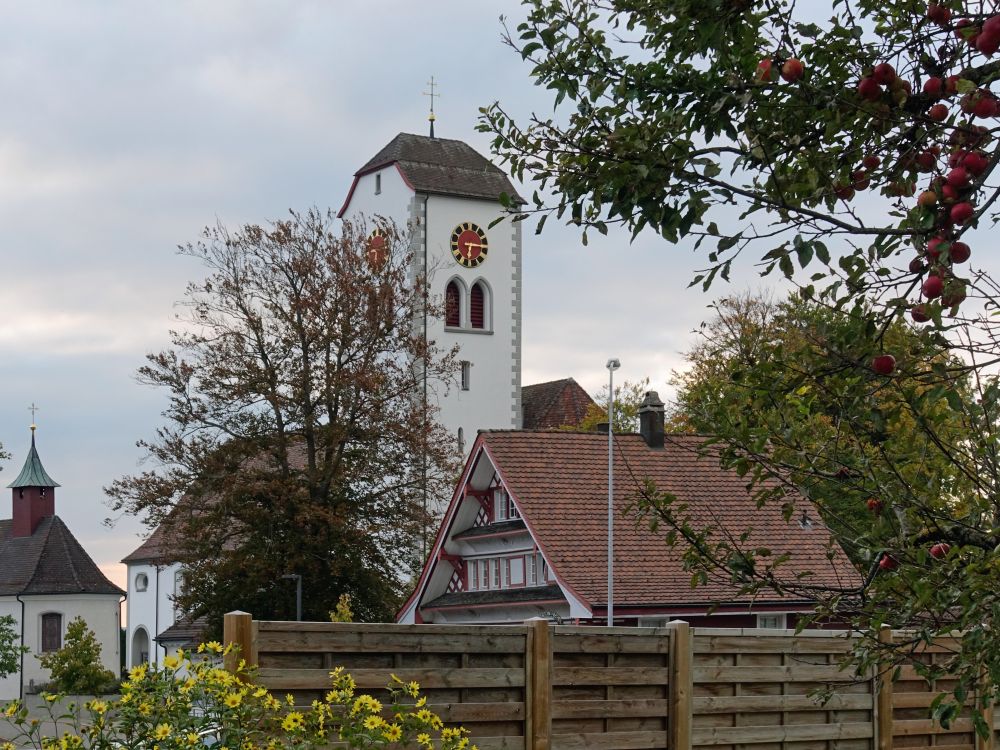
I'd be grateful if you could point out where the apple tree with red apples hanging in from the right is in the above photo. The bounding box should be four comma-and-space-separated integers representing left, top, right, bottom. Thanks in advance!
481, 0, 1000, 716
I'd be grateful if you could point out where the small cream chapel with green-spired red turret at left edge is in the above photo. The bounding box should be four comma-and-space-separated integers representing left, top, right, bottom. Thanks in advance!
0, 432, 125, 700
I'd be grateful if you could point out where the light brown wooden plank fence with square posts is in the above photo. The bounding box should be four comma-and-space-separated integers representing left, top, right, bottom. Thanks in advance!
225, 612, 1000, 750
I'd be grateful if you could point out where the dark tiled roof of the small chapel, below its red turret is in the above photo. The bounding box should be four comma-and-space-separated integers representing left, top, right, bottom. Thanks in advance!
0, 516, 125, 596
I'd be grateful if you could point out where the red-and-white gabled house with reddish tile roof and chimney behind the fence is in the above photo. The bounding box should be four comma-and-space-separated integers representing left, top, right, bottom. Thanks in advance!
397, 392, 855, 627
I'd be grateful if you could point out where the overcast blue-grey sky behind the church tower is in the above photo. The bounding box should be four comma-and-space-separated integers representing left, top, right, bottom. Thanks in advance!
0, 0, 788, 600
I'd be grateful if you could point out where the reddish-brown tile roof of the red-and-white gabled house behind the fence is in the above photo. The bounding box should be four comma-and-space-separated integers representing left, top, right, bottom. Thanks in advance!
473, 430, 857, 608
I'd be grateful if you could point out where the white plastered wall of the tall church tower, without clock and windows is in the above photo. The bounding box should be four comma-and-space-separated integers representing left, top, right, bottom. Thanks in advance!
341, 136, 522, 454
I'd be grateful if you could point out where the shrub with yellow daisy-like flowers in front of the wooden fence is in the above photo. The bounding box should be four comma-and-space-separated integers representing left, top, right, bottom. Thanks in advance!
0, 642, 475, 750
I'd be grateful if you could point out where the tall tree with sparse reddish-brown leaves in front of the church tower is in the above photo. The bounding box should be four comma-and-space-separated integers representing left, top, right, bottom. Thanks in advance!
107, 209, 457, 627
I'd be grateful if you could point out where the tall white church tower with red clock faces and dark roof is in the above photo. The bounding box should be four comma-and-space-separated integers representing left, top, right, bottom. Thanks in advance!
338, 133, 521, 453
